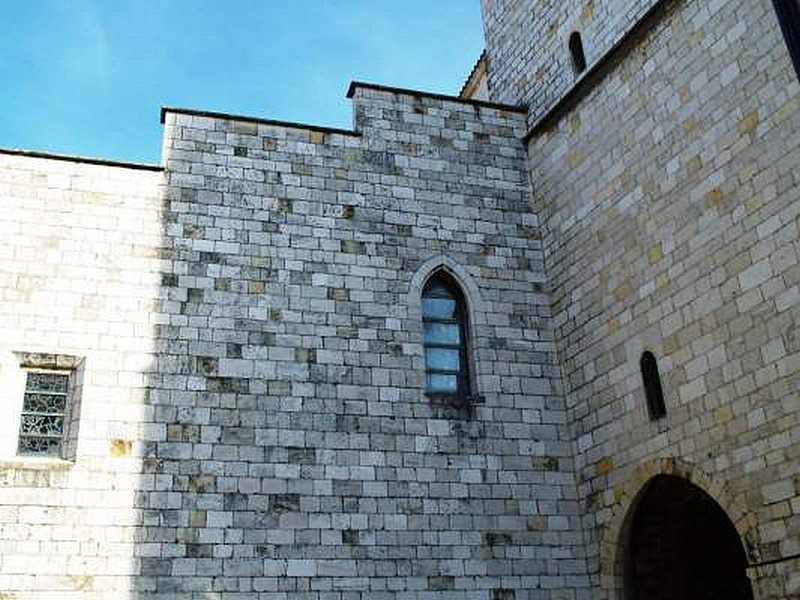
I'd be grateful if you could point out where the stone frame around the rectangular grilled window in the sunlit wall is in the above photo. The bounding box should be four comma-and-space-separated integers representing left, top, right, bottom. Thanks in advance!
13, 352, 84, 462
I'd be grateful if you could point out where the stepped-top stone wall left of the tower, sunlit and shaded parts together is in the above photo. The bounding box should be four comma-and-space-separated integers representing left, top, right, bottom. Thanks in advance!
0, 84, 587, 600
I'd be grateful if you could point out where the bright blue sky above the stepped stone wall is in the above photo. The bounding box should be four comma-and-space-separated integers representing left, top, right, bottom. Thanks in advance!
0, 0, 483, 163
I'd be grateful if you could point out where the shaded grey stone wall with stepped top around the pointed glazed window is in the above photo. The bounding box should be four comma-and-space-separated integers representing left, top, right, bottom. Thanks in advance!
133, 84, 587, 599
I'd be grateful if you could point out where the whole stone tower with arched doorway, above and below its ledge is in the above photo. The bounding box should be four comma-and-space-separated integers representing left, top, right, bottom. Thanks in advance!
483, 0, 800, 598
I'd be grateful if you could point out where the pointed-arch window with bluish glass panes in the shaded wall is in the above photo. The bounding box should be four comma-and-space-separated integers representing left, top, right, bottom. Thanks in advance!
422, 272, 470, 398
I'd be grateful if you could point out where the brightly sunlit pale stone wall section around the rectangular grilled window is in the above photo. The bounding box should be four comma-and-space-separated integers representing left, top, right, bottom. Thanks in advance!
0, 152, 162, 600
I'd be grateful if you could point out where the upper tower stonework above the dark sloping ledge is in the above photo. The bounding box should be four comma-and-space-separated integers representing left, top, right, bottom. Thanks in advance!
481, 0, 658, 124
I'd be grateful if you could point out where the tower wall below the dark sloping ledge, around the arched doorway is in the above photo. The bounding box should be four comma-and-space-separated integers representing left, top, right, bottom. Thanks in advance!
529, 0, 800, 598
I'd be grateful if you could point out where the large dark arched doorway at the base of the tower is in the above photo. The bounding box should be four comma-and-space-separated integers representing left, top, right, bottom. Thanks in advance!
624, 475, 753, 600
